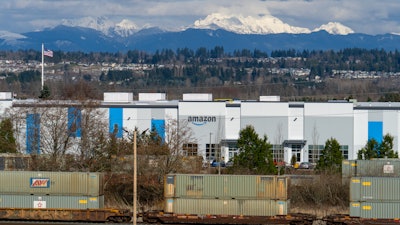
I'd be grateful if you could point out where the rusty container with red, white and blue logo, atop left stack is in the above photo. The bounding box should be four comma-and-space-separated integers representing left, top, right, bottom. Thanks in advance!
0, 171, 104, 196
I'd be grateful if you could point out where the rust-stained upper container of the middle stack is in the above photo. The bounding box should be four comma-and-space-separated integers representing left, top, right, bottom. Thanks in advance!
164, 174, 290, 200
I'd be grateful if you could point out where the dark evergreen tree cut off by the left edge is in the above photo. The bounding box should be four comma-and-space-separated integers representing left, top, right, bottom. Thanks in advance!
0, 118, 17, 153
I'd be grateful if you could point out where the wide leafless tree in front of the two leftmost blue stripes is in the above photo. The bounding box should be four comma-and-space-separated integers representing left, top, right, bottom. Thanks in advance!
9, 101, 114, 171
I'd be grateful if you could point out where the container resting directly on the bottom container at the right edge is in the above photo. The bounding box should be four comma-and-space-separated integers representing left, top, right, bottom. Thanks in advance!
350, 177, 400, 201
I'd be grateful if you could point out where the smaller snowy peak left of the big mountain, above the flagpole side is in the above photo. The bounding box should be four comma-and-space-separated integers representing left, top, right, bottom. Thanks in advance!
61, 17, 139, 37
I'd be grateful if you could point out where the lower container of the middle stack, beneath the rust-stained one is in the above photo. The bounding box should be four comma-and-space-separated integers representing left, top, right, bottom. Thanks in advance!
164, 198, 289, 216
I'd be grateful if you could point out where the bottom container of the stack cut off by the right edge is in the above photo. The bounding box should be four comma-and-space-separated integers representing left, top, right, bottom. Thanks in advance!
350, 201, 400, 219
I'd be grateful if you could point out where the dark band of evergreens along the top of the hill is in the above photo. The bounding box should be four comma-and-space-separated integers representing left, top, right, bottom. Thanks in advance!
0, 46, 400, 72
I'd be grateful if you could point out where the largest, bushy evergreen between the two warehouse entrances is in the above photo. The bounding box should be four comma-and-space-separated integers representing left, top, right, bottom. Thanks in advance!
233, 126, 277, 174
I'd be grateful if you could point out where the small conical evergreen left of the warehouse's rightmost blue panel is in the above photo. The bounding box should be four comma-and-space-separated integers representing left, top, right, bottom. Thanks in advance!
316, 138, 343, 173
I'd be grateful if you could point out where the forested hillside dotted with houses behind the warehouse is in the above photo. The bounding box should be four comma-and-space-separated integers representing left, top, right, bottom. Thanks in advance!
0, 46, 400, 100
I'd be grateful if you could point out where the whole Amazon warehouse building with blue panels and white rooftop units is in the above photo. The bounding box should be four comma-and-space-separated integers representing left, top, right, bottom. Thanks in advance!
0, 92, 400, 163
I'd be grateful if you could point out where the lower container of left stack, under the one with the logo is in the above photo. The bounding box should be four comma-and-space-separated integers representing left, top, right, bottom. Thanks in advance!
0, 194, 104, 209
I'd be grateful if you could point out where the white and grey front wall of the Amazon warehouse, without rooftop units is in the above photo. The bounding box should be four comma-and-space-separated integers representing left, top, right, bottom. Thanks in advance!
4, 95, 400, 163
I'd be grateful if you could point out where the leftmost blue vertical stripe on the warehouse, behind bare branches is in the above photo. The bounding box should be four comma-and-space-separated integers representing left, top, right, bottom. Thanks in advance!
26, 113, 40, 154
